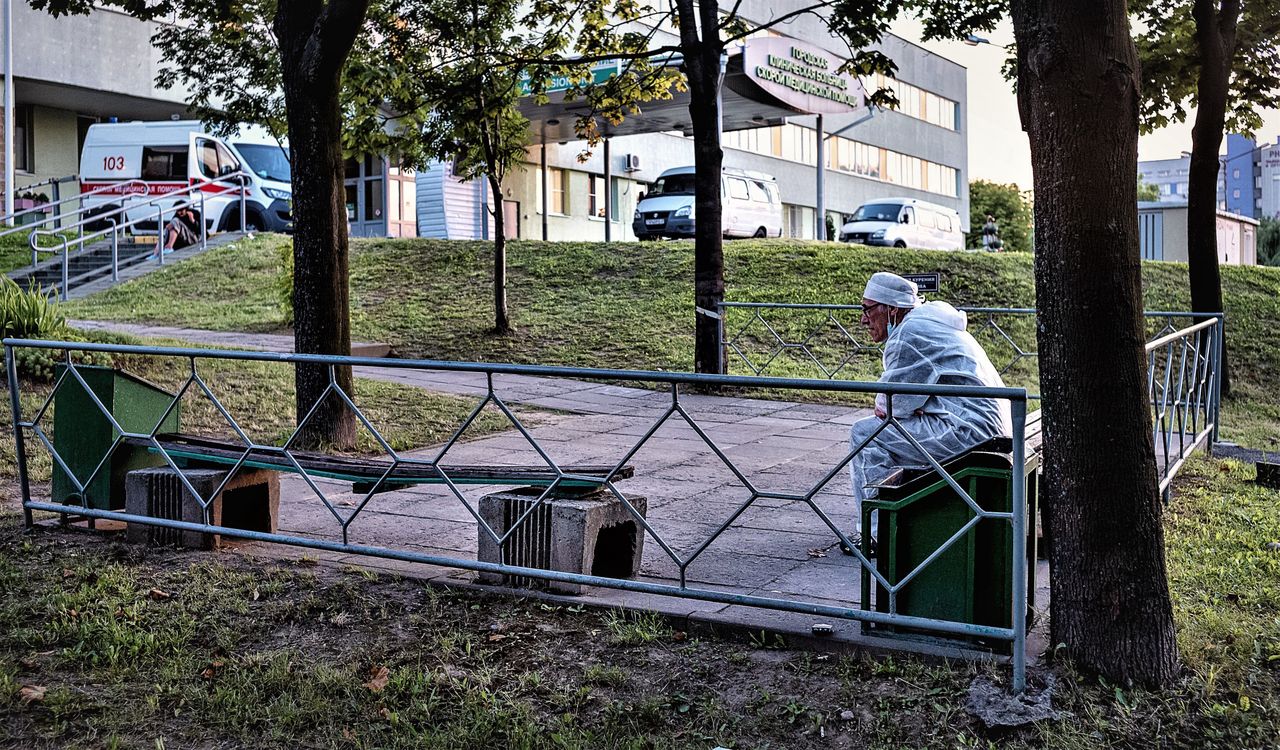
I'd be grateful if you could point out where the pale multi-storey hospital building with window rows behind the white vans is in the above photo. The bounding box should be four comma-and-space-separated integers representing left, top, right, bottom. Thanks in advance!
419, 10, 969, 241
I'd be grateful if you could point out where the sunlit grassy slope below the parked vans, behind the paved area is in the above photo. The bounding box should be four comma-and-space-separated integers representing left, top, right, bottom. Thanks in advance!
68, 237, 1280, 447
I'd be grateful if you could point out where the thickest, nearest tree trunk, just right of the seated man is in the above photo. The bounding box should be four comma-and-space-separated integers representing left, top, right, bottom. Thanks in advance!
1012, 0, 1178, 685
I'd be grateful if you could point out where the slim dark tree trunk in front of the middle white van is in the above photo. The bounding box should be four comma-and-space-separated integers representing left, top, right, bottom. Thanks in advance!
676, 0, 724, 374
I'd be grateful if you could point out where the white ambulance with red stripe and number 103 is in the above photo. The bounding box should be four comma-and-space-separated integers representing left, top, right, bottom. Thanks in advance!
81, 120, 293, 233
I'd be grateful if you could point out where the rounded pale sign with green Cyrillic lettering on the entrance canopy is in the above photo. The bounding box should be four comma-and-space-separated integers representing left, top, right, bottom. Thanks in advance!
742, 37, 867, 114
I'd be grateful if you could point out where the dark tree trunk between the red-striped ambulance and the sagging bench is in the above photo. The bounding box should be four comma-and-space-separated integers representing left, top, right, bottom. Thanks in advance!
273, 0, 369, 448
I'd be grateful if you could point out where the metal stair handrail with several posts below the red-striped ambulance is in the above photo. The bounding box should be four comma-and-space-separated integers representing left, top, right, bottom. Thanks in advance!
28, 173, 248, 299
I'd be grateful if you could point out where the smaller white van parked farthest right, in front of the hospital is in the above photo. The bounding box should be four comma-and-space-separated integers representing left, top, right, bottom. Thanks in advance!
840, 198, 964, 250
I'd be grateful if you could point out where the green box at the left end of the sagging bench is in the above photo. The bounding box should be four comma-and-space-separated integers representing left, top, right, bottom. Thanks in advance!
52, 365, 180, 511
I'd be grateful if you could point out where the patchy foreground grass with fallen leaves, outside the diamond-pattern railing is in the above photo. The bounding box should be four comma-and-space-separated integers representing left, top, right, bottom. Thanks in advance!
0, 459, 1280, 750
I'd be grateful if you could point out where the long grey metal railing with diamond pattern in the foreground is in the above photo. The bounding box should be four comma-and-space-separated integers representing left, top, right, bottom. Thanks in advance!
4, 339, 1028, 691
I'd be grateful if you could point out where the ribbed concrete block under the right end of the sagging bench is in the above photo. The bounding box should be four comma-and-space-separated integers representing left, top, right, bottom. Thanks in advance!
476, 488, 649, 594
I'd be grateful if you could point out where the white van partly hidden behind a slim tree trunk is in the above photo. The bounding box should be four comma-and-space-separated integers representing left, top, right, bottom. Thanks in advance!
631, 166, 782, 239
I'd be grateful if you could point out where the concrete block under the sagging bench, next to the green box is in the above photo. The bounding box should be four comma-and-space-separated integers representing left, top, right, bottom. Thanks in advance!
124, 466, 280, 549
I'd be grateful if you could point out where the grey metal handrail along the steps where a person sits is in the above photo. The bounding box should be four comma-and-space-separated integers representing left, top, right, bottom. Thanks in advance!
28, 172, 248, 301
